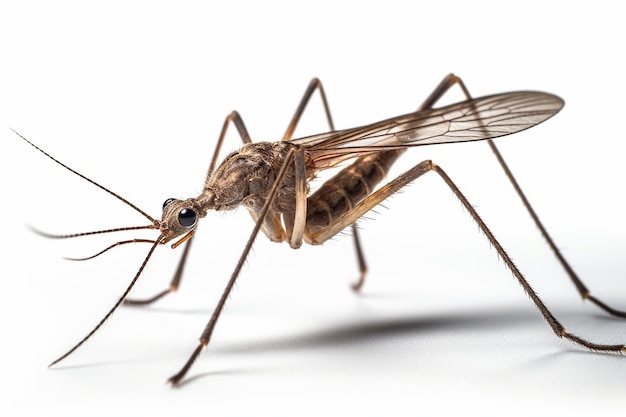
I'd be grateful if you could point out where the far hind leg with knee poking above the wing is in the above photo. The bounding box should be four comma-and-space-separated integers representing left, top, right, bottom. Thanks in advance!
418, 74, 626, 318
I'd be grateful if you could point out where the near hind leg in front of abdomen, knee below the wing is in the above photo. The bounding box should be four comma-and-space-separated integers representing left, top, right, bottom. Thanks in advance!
311, 161, 626, 353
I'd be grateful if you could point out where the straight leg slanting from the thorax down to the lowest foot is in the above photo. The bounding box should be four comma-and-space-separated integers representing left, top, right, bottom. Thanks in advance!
168, 148, 298, 385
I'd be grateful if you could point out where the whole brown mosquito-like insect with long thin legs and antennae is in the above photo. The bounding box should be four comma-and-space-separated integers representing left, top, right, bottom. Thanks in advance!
15, 74, 626, 386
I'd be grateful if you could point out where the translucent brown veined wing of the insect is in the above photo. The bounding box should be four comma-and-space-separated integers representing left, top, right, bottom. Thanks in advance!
293, 91, 564, 165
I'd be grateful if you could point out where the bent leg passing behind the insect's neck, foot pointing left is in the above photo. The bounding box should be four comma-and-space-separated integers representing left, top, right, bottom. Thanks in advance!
124, 111, 252, 306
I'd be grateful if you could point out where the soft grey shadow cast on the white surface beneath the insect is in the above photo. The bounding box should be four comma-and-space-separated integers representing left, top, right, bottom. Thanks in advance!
48, 306, 626, 387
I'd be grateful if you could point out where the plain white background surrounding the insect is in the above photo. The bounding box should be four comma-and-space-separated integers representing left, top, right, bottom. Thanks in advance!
0, 0, 626, 416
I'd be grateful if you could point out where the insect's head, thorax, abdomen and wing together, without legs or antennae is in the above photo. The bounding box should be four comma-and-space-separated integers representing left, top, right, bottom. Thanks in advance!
161, 92, 563, 248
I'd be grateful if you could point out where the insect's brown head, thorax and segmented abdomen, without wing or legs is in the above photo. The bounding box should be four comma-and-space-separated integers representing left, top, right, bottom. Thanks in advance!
166, 141, 404, 244
